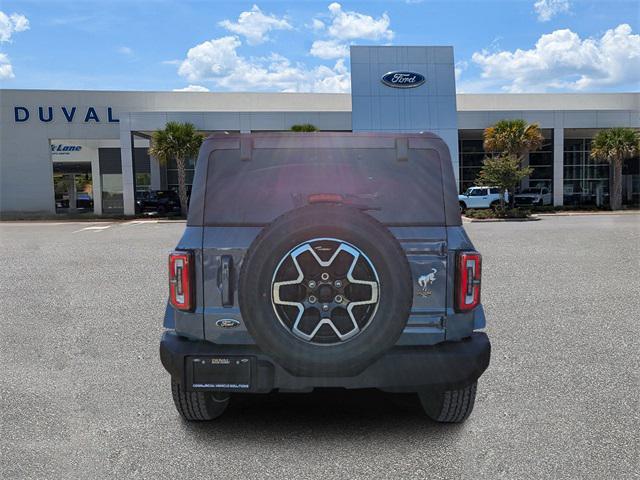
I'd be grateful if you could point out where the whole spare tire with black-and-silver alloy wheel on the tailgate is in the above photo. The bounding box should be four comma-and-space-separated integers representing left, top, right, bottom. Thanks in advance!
238, 204, 413, 376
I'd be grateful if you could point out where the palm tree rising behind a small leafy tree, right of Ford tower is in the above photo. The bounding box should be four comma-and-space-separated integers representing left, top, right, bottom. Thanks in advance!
483, 119, 544, 206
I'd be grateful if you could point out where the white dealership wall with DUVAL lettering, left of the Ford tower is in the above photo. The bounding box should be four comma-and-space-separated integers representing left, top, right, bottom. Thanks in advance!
0, 90, 351, 213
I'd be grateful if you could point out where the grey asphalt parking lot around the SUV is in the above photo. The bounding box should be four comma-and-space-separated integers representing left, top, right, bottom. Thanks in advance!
0, 215, 640, 479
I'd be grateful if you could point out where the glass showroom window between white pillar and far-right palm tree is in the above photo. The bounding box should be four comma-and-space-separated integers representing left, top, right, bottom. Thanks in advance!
564, 138, 609, 206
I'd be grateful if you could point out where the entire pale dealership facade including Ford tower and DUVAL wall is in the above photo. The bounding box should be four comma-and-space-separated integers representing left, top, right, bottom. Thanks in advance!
0, 47, 640, 213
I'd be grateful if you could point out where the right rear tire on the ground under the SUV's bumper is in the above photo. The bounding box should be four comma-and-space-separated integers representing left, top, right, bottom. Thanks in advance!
418, 382, 478, 423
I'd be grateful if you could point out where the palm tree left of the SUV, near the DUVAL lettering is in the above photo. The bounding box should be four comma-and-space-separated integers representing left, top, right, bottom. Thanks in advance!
149, 122, 203, 215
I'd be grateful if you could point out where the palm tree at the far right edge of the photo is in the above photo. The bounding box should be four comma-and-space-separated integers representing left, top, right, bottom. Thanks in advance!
590, 127, 640, 210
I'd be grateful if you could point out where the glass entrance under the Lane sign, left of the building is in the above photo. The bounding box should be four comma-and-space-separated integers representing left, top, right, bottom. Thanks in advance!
53, 162, 93, 213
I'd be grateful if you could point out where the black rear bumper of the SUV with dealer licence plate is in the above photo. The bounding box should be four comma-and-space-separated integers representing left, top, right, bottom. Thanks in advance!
160, 332, 491, 393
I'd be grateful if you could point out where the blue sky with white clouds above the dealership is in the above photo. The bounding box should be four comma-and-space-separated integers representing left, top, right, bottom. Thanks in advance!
0, 0, 640, 92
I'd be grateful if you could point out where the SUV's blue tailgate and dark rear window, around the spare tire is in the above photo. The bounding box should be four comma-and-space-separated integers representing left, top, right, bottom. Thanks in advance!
189, 133, 460, 344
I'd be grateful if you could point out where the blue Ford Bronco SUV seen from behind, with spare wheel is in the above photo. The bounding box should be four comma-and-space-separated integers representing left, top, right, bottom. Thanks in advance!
160, 132, 490, 422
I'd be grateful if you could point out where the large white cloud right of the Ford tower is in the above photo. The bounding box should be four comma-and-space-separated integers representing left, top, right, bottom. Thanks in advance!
472, 24, 640, 92
